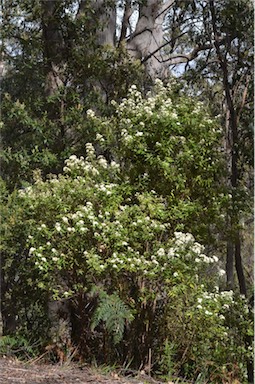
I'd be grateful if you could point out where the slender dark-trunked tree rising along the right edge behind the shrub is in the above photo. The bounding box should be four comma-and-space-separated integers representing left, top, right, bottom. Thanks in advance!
165, 1, 253, 294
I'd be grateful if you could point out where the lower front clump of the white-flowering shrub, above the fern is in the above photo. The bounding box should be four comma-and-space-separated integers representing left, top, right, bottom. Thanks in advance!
9, 144, 251, 380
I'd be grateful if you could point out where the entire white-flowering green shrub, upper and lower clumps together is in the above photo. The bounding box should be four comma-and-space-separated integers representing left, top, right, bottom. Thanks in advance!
1, 82, 252, 383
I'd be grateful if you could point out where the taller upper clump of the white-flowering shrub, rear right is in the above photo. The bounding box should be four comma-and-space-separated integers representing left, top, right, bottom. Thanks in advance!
88, 80, 230, 241
